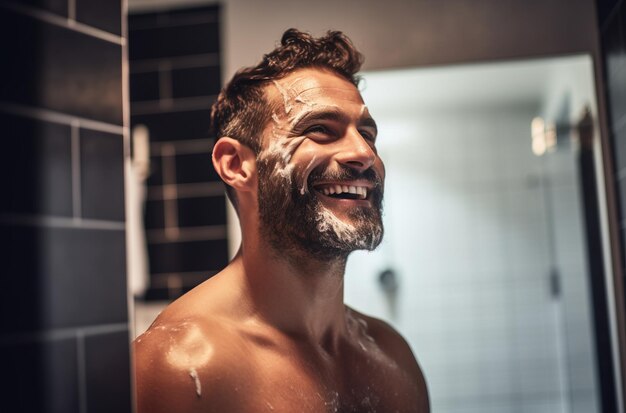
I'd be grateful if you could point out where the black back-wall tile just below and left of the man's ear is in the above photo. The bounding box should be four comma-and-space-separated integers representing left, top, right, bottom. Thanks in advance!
178, 196, 226, 227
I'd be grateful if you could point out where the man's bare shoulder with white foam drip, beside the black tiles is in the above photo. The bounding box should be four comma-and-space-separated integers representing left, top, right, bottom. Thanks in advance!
133, 310, 248, 413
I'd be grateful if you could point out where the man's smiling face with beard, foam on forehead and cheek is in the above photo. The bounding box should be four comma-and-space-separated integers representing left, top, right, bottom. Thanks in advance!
257, 69, 385, 260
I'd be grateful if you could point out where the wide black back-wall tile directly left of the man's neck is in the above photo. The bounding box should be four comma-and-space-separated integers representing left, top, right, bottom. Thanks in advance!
148, 240, 228, 273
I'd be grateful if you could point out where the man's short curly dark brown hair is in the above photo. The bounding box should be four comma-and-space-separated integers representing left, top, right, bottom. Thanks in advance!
211, 29, 363, 208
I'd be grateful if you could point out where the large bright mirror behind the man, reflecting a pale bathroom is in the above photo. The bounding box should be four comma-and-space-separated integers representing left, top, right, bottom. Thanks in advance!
346, 56, 602, 413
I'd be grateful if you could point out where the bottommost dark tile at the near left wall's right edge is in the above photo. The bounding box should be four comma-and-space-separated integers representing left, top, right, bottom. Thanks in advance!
85, 330, 131, 413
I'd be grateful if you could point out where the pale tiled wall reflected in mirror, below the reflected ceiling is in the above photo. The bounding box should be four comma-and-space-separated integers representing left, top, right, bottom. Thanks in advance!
346, 106, 560, 413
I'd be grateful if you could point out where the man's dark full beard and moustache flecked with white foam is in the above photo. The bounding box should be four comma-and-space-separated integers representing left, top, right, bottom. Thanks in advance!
257, 158, 383, 261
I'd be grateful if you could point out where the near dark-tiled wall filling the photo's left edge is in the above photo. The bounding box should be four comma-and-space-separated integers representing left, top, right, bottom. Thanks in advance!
0, 0, 131, 413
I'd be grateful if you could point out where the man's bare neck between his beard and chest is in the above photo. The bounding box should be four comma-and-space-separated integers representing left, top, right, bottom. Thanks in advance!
235, 244, 347, 345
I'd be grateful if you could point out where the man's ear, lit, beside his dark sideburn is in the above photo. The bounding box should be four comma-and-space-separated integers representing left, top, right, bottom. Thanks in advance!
212, 136, 256, 191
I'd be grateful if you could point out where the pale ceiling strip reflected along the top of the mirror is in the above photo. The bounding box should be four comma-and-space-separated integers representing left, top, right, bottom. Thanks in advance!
361, 57, 580, 113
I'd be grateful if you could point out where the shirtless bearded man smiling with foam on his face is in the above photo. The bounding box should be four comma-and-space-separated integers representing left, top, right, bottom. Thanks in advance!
134, 29, 429, 413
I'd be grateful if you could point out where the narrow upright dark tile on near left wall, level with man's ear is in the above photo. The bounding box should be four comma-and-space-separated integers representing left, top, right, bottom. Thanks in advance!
80, 130, 125, 221
